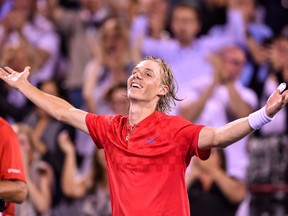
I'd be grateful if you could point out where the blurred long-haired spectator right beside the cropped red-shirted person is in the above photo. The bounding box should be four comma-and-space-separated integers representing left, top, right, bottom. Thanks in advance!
12, 124, 53, 216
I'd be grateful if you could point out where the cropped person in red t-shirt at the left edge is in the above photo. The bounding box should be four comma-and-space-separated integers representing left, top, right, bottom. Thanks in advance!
0, 117, 28, 216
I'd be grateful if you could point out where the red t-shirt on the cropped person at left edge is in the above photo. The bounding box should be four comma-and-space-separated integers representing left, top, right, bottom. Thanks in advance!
0, 117, 25, 216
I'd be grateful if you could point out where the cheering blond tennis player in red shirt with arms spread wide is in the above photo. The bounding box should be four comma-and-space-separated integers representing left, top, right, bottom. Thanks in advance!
0, 57, 288, 216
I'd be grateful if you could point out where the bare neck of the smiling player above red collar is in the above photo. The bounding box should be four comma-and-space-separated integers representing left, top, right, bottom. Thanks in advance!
129, 102, 155, 125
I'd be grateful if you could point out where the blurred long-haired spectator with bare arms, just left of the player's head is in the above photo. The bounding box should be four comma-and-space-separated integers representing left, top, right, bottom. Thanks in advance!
83, 17, 132, 114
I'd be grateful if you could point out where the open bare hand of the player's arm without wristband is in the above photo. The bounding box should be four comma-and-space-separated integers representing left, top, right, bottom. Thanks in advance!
0, 67, 31, 88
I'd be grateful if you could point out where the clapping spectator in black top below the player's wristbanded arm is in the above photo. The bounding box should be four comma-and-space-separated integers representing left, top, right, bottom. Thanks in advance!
186, 149, 246, 216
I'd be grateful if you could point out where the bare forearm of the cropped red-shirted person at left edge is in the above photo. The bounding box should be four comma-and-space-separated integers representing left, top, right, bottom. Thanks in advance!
0, 181, 28, 203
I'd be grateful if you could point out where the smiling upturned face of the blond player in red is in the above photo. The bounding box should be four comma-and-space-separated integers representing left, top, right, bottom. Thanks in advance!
127, 60, 168, 108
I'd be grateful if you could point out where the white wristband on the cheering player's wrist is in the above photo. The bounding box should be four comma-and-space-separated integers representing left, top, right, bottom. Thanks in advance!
248, 106, 274, 130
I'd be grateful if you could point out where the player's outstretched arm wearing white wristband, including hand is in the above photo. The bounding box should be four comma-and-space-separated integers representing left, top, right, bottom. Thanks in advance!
198, 83, 288, 149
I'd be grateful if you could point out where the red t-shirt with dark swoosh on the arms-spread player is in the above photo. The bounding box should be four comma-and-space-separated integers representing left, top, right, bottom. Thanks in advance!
86, 111, 210, 216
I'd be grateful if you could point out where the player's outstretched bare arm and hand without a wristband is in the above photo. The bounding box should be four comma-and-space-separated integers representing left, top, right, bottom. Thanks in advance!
0, 67, 89, 134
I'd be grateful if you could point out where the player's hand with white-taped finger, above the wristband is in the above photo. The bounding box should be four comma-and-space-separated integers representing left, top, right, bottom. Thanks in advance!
266, 83, 288, 118
